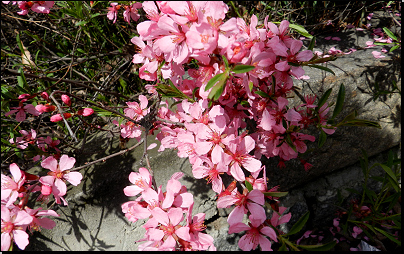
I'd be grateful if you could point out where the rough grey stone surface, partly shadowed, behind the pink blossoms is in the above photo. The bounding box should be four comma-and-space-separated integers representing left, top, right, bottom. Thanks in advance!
26, 25, 401, 251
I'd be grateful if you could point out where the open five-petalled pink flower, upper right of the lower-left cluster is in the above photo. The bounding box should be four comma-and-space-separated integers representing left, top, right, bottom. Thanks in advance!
39, 154, 83, 205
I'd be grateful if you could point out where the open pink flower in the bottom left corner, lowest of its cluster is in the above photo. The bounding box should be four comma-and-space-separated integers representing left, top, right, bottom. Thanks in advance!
1, 205, 32, 251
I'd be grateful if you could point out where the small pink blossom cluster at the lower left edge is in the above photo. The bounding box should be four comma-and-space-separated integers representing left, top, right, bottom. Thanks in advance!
1, 155, 82, 251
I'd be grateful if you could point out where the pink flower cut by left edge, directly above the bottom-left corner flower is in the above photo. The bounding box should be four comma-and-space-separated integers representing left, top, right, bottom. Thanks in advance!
1, 163, 25, 207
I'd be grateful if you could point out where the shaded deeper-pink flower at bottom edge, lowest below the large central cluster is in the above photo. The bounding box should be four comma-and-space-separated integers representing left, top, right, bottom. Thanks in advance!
229, 215, 278, 251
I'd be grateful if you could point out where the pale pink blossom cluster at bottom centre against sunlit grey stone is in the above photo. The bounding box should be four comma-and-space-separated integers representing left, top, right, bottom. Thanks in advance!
122, 168, 216, 251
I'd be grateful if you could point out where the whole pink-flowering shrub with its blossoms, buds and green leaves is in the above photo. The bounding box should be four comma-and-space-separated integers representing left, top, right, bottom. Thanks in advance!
1, 1, 398, 251
